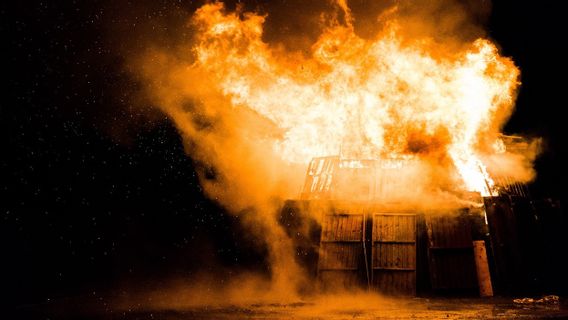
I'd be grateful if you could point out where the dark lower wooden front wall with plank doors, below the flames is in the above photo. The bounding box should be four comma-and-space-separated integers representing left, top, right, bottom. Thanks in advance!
280, 200, 504, 295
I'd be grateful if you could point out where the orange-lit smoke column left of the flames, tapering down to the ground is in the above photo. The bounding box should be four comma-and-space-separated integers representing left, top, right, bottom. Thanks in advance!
135, 47, 303, 295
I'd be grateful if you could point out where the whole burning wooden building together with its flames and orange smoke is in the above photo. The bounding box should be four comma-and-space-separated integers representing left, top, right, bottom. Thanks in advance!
135, 1, 556, 300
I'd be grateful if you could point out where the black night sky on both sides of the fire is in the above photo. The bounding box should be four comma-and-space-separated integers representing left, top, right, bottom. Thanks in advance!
0, 0, 568, 310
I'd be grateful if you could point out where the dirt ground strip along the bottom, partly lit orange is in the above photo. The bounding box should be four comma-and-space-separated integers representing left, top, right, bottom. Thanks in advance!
14, 296, 568, 320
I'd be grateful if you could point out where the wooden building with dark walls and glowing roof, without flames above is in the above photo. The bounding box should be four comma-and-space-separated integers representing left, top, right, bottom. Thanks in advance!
281, 137, 560, 296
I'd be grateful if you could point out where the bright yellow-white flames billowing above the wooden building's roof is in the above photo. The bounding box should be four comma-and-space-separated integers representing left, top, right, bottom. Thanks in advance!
187, 1, 519, 195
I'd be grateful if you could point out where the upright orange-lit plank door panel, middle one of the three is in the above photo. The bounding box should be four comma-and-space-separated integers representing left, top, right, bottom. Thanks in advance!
371, 213, 416, 295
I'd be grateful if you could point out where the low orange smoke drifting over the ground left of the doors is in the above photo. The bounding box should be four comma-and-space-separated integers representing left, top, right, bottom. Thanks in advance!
114, 274, 400, 319
